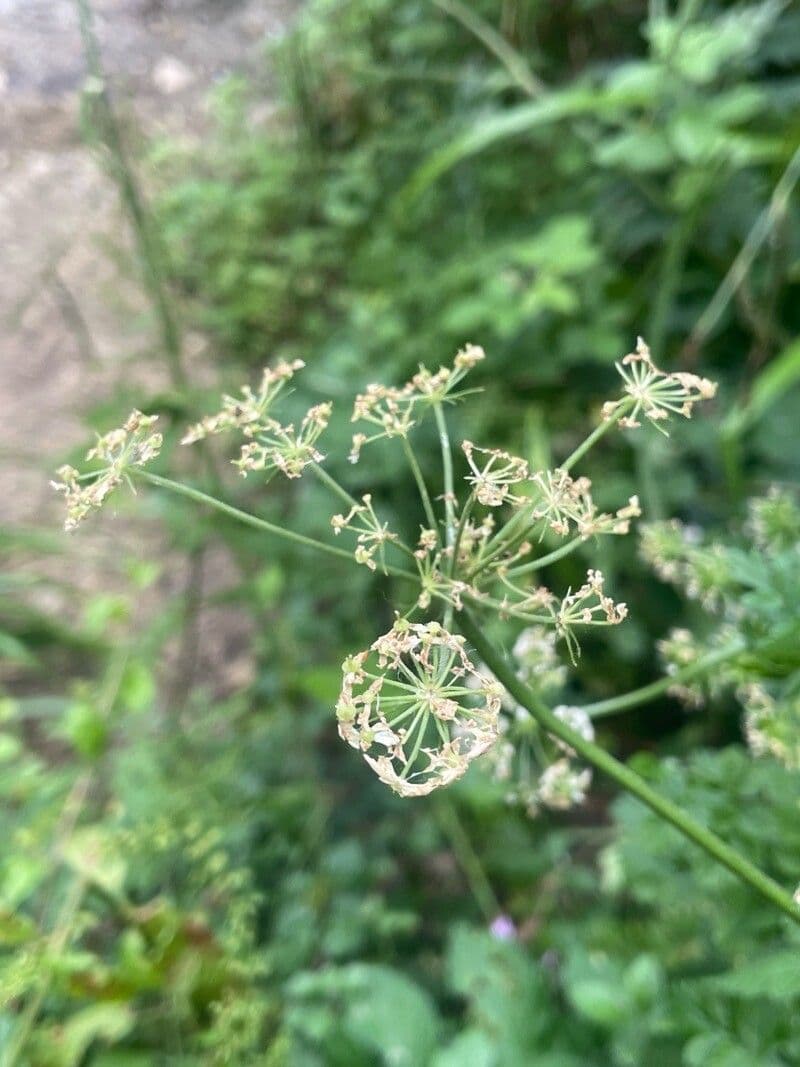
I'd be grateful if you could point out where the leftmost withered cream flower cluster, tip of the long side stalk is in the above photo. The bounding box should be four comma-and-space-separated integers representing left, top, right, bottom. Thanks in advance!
50, 411, 162, 530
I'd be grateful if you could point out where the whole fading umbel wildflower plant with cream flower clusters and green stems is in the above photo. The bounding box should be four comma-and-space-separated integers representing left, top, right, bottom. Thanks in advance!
53, 339, 800, 920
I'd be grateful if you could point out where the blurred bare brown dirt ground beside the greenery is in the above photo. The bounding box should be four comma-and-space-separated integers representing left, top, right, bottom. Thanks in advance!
0, 0, 293, 691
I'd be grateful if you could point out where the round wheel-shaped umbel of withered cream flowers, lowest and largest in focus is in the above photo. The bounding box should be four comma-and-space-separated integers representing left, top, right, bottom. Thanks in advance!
336, 619, 501, 796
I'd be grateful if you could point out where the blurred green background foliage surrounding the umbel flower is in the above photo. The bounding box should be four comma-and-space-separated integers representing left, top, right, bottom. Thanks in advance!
0, 0, 800, 1067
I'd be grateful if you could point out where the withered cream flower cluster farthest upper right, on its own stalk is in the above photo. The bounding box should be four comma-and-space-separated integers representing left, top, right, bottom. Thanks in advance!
603, 337, 717, 434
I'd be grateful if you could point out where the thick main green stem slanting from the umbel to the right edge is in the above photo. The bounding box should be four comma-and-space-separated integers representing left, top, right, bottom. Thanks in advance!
460, 612, 800, 924
